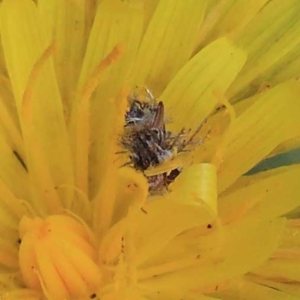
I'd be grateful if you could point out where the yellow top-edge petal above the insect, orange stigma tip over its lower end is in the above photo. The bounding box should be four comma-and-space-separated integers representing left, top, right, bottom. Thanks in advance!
78, 0, 143, 99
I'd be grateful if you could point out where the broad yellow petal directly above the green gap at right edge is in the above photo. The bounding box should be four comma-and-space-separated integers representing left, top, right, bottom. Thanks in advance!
218, 81, 300, 192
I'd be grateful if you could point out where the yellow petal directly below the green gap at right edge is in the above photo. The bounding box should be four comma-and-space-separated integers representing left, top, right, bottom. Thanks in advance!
219, 166, 300, 222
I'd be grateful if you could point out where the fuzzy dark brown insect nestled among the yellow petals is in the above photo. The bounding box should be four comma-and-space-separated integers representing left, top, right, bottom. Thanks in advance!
122, 89, 180, 192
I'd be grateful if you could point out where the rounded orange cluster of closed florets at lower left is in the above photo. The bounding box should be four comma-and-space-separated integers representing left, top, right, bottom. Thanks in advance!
19, 215, 102, 299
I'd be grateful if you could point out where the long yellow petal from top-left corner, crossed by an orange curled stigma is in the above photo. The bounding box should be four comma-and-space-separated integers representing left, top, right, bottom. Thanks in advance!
1, 0, 73, 205
